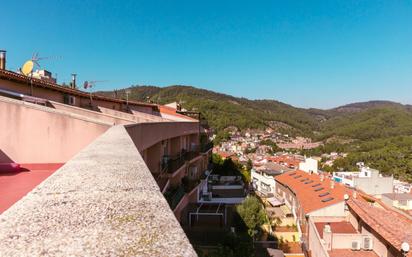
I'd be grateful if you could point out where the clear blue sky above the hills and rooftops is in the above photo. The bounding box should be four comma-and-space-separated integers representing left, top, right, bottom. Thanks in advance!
0, 0, 412, 108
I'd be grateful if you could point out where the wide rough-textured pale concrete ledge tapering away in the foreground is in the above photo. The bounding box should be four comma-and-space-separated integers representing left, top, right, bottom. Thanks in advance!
0, 126, 196, 256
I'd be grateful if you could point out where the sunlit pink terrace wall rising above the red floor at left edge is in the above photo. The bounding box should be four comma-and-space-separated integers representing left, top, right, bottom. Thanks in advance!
0, 97, 108, 163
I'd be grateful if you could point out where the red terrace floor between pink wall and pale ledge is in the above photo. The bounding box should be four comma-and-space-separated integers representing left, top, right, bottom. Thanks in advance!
0, 163, 63, 214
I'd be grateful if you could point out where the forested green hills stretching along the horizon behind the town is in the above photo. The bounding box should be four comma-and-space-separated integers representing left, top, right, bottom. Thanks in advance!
99, 86, 412, 182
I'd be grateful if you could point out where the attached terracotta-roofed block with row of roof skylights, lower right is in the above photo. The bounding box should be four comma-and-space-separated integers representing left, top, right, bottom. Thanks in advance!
276, 170, 412, 257
